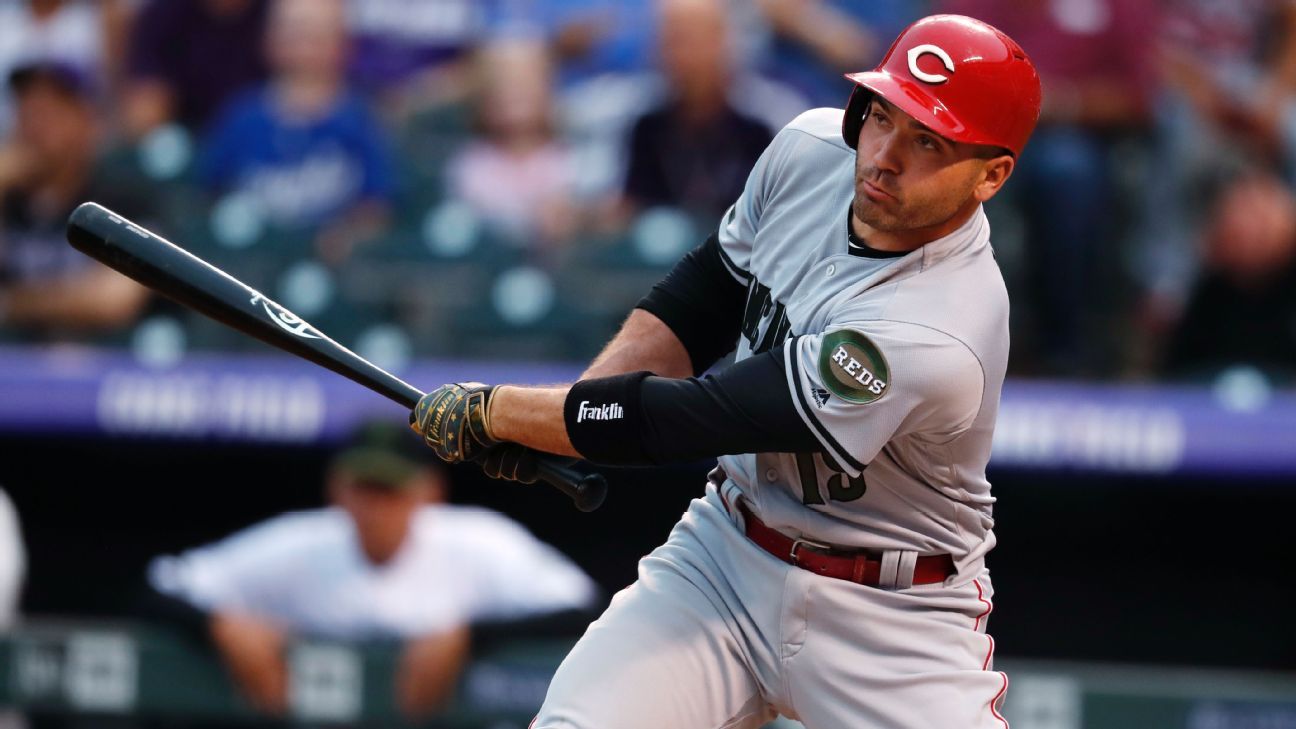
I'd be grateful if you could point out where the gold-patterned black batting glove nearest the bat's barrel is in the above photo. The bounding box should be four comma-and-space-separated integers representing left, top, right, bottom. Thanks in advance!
410, 383, 499, 463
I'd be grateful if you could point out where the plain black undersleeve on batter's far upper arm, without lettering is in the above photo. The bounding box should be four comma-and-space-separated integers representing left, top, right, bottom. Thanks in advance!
638, 233, 746, 375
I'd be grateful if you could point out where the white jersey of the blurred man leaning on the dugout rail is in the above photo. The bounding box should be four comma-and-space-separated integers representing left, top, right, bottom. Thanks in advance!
149, 505, 597, 639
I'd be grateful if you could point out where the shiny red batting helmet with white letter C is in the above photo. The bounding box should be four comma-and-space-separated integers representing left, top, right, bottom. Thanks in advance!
841, 16, 1039, 156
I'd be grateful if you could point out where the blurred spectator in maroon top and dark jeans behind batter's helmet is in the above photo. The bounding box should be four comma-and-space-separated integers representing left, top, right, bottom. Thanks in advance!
942, 0, 1157, 375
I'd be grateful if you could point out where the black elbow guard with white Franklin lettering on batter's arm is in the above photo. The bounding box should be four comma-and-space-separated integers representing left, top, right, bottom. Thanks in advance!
562, 371, 652, 464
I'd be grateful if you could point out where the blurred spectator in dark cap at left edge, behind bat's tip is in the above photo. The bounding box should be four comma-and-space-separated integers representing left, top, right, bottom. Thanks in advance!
0, 62, 149, 339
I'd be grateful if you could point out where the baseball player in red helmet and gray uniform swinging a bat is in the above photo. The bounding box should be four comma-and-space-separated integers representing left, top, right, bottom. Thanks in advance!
412, 16, 1041, 729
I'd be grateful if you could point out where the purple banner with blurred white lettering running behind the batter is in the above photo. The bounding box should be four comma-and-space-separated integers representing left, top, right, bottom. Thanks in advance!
0, 348, 1296, 476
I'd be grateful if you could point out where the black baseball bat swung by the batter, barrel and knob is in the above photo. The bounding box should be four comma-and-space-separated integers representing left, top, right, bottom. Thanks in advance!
67, 202, 608, 511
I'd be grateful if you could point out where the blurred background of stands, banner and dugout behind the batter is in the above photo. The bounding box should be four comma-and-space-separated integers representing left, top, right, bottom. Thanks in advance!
0, 0, 1296, 729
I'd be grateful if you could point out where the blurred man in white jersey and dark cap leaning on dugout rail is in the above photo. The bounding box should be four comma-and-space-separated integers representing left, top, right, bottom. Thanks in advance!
149, 422, 596, 713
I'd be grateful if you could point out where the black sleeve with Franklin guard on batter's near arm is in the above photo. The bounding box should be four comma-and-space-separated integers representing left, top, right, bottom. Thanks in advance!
564, 348, 823, 466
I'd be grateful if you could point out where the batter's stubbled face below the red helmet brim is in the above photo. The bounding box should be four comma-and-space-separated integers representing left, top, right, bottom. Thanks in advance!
853, 99, 1013, 245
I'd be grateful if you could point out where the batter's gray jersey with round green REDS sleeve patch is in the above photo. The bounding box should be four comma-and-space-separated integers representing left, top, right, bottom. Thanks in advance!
719, 109, 1008, 571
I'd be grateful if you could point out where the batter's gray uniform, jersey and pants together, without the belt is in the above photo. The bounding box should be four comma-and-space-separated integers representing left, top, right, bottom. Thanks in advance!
534, 109, 1008, 729
